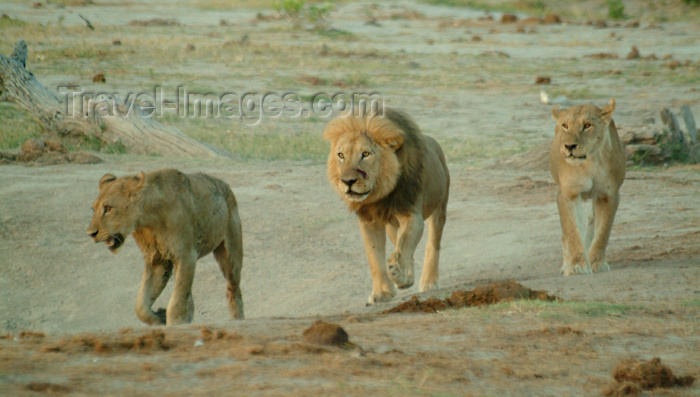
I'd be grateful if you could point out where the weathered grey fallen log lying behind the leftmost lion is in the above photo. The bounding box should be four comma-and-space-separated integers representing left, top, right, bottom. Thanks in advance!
0, 40, 222, 158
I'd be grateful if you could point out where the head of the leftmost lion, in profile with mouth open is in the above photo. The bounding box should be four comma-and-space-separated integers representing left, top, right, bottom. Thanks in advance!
87, 172, 145, 253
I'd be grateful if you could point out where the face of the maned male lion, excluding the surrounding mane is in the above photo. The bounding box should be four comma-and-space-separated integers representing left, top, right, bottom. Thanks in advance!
330, 134, 396, 202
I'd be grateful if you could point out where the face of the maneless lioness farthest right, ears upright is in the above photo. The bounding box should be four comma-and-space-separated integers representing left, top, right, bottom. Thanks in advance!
552, 99, 615, 164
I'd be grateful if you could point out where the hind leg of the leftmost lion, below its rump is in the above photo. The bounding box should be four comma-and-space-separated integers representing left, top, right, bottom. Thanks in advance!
214, 216, 244, 320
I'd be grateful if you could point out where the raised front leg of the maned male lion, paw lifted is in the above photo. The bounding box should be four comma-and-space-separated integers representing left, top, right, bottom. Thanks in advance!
386, 213, 423, 289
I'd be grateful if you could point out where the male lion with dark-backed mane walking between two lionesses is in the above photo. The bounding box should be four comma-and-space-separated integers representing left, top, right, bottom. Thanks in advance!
323, 109, 450, 303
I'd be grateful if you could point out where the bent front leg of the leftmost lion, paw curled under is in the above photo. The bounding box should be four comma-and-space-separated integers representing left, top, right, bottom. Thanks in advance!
136, 259, 173, 325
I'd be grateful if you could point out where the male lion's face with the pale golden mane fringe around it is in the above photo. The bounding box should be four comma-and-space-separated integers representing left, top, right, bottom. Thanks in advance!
324, 111, 403, 204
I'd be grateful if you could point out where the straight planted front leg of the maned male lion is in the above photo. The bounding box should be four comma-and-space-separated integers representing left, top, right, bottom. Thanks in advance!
360, 219, 396, 304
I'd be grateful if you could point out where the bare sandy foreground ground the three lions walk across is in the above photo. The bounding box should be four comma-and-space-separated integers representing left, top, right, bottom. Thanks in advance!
0, 160, 700, 395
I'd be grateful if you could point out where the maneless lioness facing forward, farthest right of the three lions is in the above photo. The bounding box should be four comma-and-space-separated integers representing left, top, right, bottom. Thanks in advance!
549, 99, 625, 276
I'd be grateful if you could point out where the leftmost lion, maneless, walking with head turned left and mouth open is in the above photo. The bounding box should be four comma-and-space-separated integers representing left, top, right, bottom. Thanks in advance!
87, 169, 243, 325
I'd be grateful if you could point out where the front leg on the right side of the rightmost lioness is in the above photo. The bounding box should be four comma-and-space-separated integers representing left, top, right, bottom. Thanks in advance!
588, 192, 620, 272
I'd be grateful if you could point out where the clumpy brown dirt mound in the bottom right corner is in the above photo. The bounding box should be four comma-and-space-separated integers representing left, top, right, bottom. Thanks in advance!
603, 357, 695, 396
